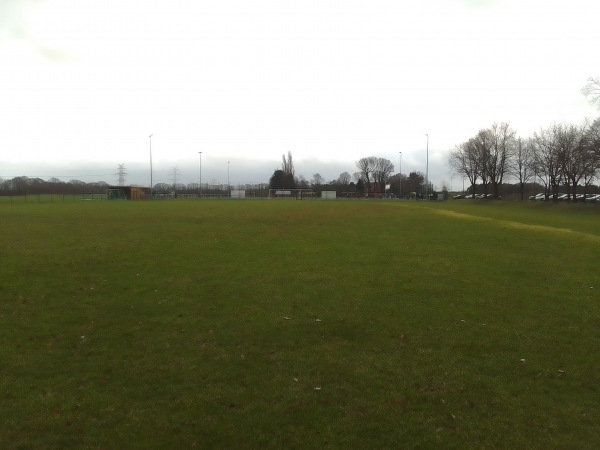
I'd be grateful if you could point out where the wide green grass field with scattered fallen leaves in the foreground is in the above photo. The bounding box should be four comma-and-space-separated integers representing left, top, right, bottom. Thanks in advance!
0, 200, 600, 449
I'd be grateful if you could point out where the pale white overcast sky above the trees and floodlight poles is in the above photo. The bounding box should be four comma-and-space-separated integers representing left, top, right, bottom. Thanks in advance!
0, 0, 600, 186
